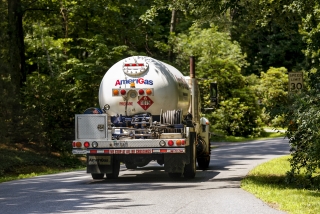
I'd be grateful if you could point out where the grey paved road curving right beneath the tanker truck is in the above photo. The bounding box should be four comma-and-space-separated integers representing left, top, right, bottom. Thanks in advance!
0, 138, 289, 214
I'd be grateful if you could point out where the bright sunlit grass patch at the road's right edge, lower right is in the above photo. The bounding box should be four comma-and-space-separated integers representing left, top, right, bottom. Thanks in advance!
241, 156, 320, 214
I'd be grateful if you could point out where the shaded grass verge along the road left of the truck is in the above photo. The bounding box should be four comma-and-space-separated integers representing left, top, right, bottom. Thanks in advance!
0, 144, 85, 182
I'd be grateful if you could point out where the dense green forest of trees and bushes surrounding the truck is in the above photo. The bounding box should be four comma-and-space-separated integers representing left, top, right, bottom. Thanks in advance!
0, 0, 320, 182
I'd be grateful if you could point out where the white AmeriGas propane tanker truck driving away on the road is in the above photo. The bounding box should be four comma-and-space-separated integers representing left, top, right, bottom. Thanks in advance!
72, 56, 216, 179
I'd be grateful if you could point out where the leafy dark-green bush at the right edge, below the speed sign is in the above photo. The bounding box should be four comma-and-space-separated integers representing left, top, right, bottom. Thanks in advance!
287, 89, 320, 187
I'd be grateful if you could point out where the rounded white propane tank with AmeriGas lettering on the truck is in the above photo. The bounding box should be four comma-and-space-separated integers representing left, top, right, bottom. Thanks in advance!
99, 56, 190, 116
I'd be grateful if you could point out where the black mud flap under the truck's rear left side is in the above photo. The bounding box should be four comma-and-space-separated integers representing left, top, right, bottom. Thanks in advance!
87, 154, 113, 174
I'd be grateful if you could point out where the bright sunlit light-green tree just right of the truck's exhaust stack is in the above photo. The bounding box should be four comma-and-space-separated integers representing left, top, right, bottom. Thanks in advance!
172, 25, 260, 136
